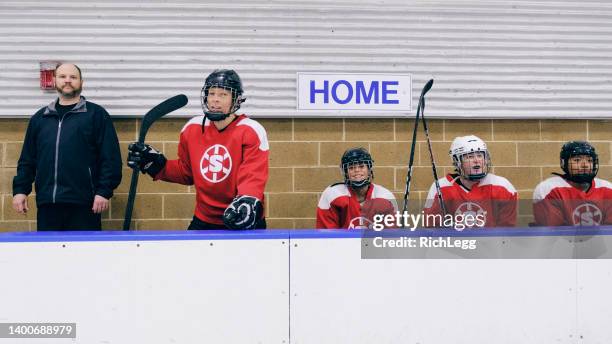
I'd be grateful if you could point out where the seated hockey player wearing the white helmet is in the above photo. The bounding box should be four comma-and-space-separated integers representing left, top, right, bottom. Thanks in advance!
423, 135, 518, 228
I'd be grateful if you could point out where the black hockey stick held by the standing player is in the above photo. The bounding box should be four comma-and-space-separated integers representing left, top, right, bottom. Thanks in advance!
123, 94, 187, 231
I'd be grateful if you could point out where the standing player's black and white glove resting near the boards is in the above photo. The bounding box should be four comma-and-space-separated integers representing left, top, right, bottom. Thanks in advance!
223, 196, 263, 229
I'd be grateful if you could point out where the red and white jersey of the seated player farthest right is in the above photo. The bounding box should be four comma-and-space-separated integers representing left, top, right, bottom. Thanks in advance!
533, 176, 612, 226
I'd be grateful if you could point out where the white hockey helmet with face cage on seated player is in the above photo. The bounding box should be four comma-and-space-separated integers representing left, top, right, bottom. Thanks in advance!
449, 135, 491, 180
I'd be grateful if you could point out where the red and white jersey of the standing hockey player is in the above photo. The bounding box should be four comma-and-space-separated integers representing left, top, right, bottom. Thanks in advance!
155, 115, 269, 225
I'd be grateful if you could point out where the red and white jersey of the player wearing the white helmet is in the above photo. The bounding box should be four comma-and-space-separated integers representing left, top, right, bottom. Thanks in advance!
423, 173, 518, 227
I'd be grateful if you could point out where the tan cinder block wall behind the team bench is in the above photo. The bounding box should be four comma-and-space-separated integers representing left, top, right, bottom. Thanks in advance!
0, 119, 612, 231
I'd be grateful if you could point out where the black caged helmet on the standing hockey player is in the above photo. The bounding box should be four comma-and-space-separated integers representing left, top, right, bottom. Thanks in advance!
200, 69, 245, 121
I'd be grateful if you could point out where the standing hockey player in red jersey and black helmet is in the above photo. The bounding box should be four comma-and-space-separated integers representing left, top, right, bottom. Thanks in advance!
128, 69, 269, 230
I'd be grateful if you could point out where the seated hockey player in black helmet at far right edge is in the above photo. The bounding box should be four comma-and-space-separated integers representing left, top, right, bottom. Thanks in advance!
533, 141, 612, 226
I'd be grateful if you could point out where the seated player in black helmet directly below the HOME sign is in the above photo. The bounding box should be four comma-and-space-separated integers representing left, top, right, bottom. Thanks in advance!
317, 148, 397, 229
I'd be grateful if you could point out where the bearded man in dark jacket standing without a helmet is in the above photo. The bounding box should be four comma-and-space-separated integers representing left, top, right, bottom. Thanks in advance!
13, 63, 121, 231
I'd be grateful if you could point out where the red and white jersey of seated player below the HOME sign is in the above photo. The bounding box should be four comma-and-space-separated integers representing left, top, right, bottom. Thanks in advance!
317, 183, 397, 229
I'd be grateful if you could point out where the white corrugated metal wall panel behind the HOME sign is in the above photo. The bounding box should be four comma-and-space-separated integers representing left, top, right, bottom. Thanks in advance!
0, 0, 612, 118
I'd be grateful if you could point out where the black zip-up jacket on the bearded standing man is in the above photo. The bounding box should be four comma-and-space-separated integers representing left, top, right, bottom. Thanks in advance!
13, 97, 121, 205
